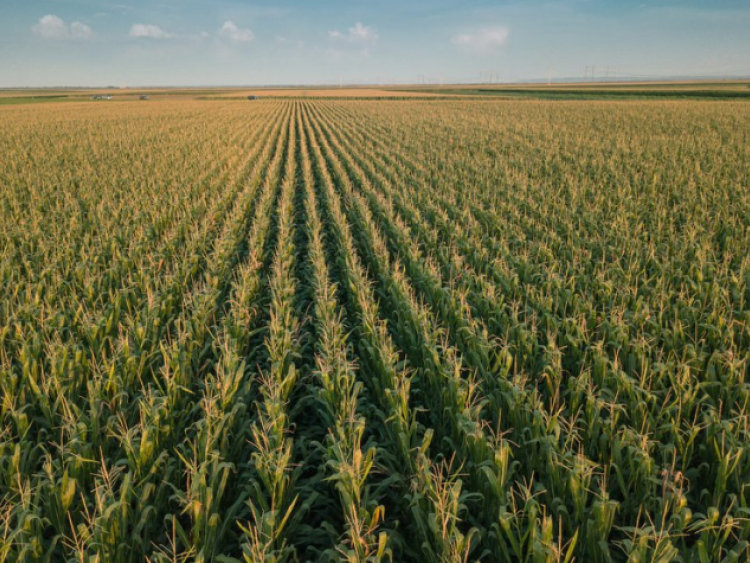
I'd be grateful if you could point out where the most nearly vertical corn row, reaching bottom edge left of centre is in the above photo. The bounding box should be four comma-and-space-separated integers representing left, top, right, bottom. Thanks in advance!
242, 103, 314, 563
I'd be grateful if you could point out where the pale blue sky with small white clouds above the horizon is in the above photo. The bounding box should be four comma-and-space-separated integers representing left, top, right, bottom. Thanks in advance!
0, 0, 750, 87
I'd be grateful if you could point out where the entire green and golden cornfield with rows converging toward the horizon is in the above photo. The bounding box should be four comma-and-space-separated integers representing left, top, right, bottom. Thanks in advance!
0, 97, 750, 563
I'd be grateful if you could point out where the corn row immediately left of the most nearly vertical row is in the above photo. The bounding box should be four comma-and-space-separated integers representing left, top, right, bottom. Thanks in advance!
148, 99, 291, 561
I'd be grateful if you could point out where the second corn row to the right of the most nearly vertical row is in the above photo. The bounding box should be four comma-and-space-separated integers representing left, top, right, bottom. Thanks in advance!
309, 102, 488, 562
